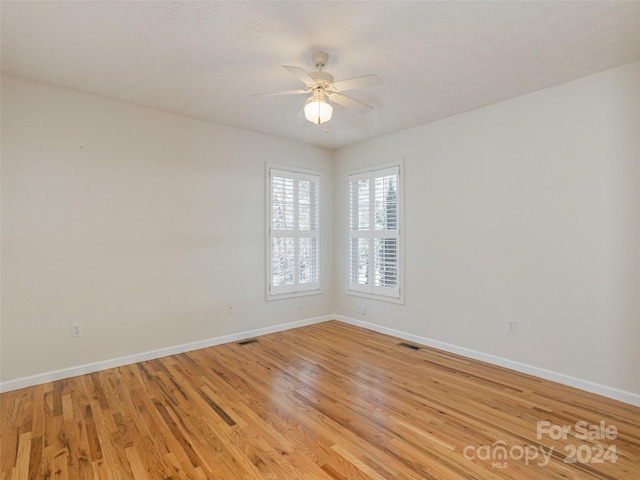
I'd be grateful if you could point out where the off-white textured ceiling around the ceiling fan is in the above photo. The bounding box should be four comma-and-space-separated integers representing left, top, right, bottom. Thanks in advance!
0, 1, 640, 148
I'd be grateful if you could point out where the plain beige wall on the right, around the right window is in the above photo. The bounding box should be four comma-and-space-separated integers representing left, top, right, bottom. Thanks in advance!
334, 63, 640, 394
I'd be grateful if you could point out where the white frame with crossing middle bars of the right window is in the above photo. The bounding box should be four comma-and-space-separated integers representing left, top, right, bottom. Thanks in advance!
346, 160, 404, 304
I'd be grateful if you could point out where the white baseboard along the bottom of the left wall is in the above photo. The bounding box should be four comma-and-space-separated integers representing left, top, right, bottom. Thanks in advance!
0, 315, 335, 392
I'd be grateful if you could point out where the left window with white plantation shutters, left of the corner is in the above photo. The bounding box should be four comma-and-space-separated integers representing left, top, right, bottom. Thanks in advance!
267, 167, 320, 299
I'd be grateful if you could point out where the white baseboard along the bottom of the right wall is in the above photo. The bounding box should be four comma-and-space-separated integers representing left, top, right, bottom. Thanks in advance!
334, 315, 640, 407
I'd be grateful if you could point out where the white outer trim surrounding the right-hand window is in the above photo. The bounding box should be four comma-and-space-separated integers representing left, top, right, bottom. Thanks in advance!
345, 160, 404, 304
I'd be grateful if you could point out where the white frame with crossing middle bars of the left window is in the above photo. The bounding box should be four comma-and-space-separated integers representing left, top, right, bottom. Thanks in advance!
265, 163, 323, 301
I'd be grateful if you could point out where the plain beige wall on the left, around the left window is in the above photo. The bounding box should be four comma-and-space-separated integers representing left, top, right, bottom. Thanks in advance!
1, 76, 333, 381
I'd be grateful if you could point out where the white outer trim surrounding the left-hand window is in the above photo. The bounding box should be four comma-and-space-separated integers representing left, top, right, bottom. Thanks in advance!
265, 163, 324, 301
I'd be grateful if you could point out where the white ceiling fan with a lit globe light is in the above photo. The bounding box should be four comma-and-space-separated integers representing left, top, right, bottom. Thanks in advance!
252, 52, 382, 124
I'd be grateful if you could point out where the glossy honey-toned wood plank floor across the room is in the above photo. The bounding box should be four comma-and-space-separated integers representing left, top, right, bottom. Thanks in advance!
0, 321, 640, 480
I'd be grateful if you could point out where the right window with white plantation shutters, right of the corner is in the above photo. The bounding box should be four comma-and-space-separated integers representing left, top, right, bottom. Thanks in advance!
348, 165, 401, 300
